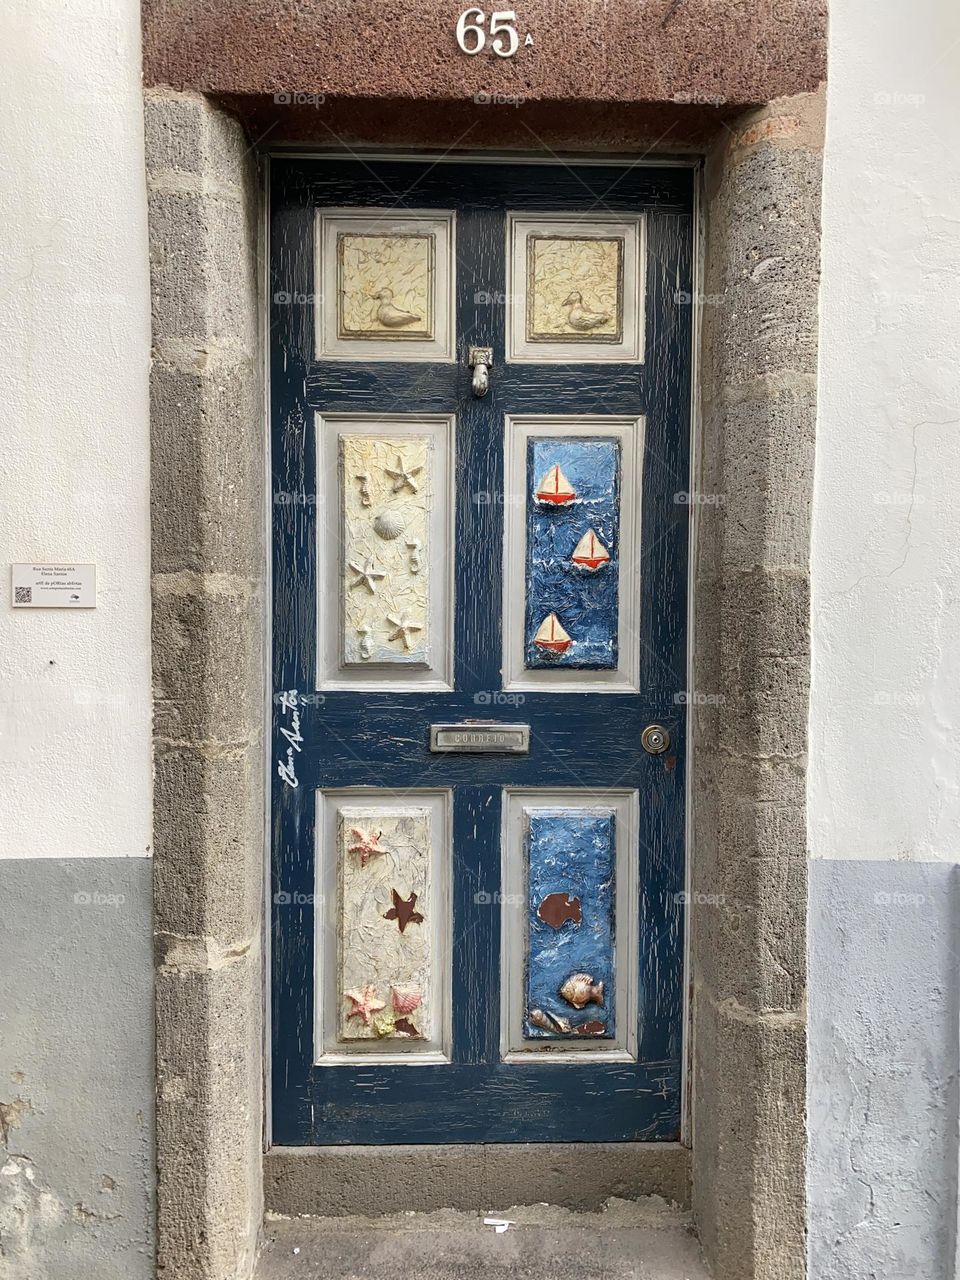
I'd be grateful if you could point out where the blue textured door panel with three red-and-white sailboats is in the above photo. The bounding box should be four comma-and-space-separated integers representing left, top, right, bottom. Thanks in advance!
525, 436, 620, 671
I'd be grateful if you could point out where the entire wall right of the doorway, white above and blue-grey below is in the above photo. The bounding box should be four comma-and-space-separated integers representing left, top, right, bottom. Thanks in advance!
808, 0, 960, 1280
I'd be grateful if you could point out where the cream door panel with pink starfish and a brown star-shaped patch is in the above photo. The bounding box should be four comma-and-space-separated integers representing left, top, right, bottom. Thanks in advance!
338, 805, 435, 1042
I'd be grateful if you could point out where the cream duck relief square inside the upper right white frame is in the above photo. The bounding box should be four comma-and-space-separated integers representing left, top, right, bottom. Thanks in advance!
526, 236, 623, 342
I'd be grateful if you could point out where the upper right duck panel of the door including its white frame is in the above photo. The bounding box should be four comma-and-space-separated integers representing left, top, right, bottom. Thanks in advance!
507, 212, 645, 364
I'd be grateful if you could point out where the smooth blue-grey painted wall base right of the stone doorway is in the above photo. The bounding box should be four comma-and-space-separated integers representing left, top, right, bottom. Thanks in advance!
809, 861, 960, 1280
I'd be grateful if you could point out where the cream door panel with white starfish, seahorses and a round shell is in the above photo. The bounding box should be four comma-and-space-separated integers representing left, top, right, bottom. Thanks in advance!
339, 435, 431, 667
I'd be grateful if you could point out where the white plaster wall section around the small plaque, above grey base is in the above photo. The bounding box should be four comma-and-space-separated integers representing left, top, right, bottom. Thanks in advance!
0, 0, 151, 858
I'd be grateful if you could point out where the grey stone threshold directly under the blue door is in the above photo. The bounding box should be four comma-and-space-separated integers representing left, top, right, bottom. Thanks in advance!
264, 1142, 690, 1216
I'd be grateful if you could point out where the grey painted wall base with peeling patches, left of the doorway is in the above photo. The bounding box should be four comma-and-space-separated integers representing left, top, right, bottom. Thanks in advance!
0, 858, 154, 1280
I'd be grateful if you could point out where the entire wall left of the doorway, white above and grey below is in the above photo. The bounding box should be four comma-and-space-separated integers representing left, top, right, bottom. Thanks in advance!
0, 0, 154, 1280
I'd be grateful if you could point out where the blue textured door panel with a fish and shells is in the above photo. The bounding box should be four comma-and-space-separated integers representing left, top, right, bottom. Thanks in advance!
524, 809, 616, 1039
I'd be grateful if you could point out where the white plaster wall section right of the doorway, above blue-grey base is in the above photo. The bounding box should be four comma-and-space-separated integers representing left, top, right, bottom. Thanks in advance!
808, 0, 960, 860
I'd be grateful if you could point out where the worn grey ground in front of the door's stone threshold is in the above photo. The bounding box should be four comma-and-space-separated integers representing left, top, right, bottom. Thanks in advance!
257, 1198, 709, 1280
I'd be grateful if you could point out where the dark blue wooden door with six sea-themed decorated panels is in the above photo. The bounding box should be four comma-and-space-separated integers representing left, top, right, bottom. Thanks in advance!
270, 157, 692, 1144
